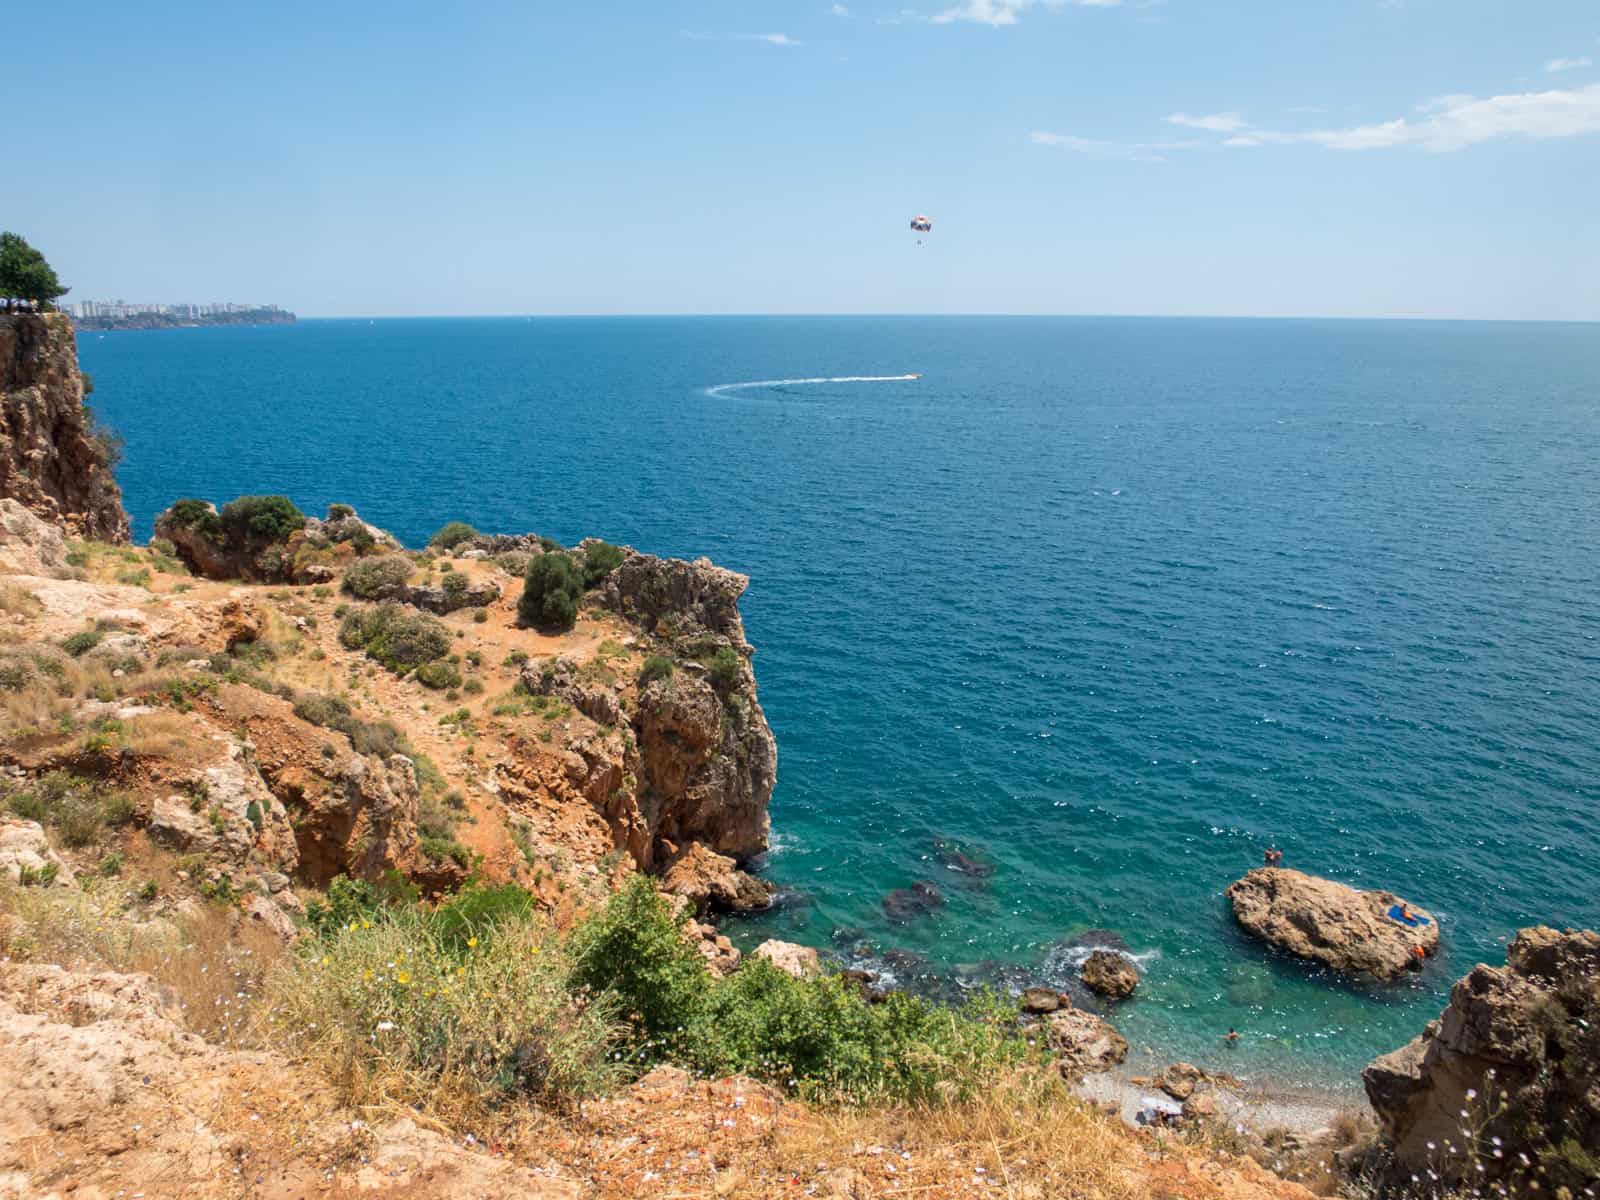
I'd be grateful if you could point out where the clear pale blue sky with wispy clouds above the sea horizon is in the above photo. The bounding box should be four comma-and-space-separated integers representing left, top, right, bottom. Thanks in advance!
12, 0, 1600, 320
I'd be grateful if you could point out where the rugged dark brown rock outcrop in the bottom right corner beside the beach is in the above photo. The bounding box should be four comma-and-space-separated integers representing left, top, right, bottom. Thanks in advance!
1362, 926, 1600, 1195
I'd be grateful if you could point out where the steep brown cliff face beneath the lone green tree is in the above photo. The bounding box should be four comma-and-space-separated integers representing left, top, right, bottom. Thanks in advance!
0, 314, 128, 542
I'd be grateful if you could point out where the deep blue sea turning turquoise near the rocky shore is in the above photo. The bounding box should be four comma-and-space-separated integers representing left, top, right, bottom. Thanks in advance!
80, 318, 1600, 1083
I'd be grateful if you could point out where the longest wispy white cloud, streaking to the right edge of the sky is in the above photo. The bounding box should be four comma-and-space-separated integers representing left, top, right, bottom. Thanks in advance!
1032, 83, 1600, 162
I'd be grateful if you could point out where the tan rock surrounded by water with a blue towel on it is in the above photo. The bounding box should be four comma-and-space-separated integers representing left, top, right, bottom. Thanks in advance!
1227, 867, 1438, 979
